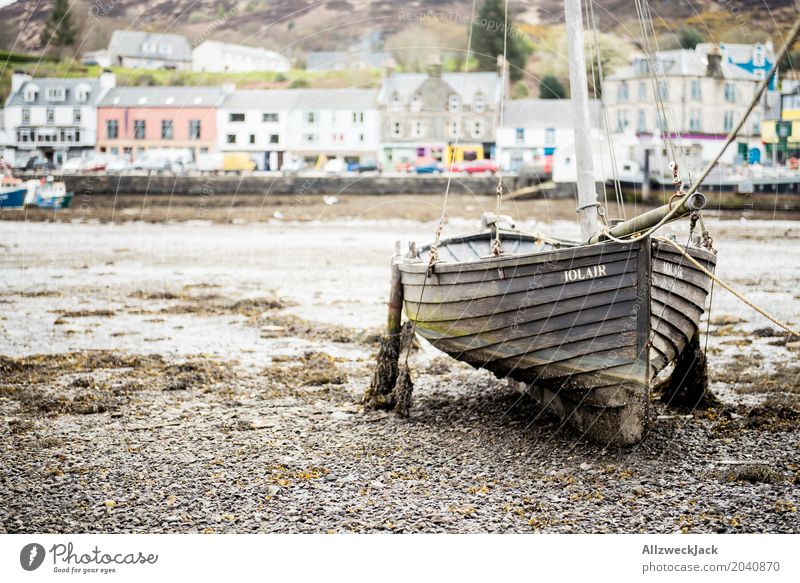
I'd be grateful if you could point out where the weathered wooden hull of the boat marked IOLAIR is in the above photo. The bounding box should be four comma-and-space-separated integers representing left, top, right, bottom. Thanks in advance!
399, 221, 716, 444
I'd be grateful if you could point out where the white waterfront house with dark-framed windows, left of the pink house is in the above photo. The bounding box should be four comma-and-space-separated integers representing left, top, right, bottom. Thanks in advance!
3, 72, 116, 165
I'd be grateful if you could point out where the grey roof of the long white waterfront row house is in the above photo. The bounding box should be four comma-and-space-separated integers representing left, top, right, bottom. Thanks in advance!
223, 89, 378, 111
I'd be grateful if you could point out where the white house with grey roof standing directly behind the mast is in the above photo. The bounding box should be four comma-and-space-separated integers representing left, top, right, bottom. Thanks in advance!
497, 99, 601, 172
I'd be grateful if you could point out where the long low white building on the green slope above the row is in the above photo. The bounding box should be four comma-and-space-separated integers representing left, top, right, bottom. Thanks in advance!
192, 40, 292, 73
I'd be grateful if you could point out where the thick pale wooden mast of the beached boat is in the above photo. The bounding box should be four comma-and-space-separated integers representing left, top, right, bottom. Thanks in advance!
564, 0, 599, 241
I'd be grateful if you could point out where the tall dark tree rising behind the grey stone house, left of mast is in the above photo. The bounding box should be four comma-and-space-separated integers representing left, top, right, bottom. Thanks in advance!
472, 0, 528, 80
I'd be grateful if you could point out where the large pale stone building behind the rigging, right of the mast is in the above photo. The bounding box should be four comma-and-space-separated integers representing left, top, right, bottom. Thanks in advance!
603, 49, 768, 172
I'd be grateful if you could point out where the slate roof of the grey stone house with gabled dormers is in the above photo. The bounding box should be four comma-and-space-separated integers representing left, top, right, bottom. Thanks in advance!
378, 71, 502, 104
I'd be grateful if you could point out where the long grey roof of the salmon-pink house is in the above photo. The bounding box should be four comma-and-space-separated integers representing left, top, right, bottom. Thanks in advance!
98, 87, 226, 107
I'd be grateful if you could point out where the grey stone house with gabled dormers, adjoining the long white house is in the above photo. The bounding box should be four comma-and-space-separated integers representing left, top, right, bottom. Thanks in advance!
378, 63, 508, 168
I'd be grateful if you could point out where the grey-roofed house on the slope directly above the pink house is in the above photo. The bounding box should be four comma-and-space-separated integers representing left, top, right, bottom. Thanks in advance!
104, 30, 192, 70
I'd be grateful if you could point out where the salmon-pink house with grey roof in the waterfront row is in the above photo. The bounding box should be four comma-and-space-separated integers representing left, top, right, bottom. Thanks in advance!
97, 85, 233, 160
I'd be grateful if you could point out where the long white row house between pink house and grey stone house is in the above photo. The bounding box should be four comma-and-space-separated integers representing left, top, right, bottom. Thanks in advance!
217, 89, 380, 170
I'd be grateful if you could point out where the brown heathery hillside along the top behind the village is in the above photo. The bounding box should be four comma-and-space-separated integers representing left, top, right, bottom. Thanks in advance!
0, 0, 797, 57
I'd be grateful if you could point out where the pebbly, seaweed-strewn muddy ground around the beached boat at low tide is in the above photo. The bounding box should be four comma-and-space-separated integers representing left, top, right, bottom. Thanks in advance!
0, 197, 800, 532
